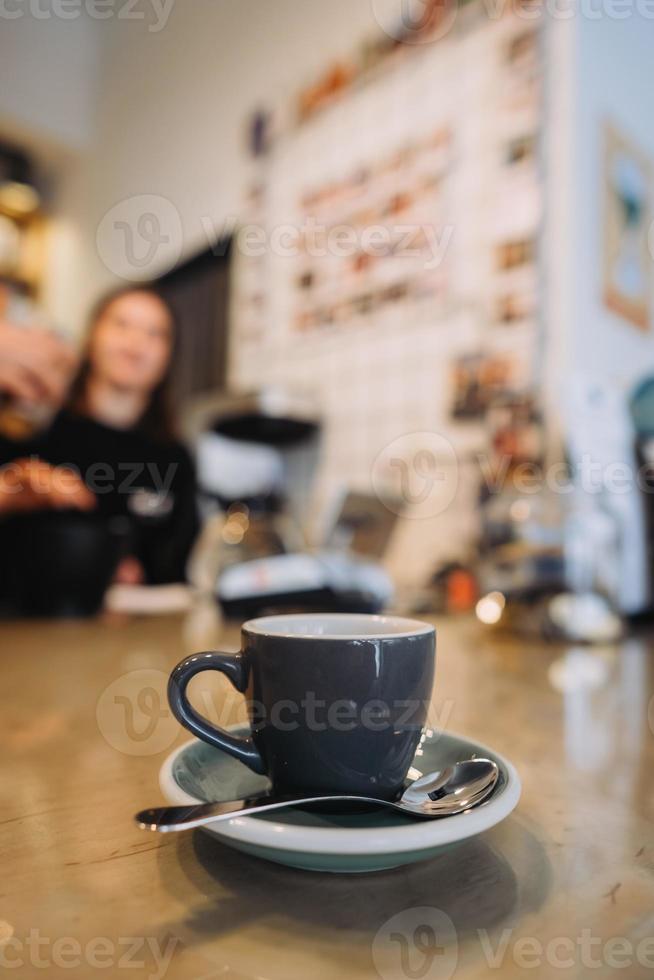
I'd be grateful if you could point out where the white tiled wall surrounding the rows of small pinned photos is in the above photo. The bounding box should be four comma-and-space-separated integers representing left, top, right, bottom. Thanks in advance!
231, 9, 541, 581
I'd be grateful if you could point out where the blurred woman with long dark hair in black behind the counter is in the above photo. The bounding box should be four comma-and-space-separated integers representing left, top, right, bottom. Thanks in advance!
5, 287, 197, 584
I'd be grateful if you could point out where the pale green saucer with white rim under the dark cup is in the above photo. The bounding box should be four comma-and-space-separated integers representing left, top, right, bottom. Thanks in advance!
159, 729, 521, 872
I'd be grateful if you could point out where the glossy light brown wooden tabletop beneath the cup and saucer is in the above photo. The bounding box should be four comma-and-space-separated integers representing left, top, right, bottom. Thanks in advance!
0, 610, 654, 980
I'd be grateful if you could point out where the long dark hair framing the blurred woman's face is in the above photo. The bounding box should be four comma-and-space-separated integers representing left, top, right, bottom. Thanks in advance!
66, 285, 179, 442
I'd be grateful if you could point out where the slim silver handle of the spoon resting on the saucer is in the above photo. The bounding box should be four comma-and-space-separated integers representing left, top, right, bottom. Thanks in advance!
134, 795, 388, 833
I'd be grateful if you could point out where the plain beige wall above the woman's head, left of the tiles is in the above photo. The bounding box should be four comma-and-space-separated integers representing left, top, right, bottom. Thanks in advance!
51, 0, 400, 324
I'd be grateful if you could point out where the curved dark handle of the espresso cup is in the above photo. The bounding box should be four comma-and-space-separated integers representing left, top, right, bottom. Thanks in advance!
168, 653, 266, 775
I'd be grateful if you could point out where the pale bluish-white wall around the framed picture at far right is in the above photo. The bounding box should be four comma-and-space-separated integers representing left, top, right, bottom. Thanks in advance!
559, 13, 654, 612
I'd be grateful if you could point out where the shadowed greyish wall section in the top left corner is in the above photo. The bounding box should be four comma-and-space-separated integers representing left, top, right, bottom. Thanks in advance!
0, 0, 110, 330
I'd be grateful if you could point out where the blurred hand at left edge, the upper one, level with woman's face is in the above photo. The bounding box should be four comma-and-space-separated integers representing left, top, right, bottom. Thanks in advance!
0, 320, 77, 405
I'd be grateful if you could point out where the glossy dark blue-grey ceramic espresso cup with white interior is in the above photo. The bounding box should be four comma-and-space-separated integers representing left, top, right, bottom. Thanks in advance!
168, 614, 436, 799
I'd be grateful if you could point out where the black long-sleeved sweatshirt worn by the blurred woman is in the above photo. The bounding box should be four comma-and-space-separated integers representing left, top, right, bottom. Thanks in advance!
0, 410, 198, 584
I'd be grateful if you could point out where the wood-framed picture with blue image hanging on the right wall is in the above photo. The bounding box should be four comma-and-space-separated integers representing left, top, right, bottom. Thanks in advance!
602, 121, 654, 330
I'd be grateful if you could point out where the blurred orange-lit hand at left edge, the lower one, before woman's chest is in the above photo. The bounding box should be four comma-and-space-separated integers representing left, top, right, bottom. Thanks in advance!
0, 459, 96, 514
